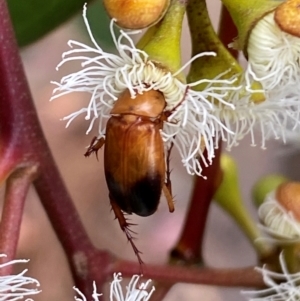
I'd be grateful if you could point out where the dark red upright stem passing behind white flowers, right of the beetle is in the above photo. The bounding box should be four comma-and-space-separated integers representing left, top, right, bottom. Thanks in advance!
171, 1, 238, 263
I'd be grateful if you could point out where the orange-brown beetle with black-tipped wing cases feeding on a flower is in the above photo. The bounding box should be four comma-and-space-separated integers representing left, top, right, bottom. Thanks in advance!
85, 89, 174, 263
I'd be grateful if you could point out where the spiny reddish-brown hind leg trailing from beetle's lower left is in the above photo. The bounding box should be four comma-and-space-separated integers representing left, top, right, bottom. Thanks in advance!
110, 199, 143, 265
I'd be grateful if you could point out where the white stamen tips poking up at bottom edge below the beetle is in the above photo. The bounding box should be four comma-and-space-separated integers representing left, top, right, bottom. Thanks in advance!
74, 273, 155, 301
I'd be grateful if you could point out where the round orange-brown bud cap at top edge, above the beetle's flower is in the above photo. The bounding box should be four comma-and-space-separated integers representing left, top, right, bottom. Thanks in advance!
103, 0, 170, 29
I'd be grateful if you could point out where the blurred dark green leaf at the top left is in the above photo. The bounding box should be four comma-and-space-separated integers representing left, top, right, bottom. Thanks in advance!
7, 0, 113, 47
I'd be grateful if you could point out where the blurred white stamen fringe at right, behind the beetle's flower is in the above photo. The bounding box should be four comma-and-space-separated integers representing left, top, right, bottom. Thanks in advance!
214, 85, 300, 150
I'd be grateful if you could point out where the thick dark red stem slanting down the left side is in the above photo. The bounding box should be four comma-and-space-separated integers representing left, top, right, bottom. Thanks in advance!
0, 0, 109, 294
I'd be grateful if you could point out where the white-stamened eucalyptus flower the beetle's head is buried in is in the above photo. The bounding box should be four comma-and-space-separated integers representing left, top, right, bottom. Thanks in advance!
52, 6, 237, 175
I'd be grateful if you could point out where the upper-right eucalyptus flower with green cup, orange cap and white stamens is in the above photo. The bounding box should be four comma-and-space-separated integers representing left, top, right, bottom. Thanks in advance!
217, 0, 300, 149
